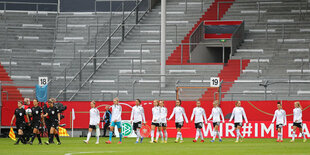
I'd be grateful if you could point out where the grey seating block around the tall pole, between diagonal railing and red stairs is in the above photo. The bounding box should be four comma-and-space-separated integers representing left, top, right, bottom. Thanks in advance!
62, 0, 230, 100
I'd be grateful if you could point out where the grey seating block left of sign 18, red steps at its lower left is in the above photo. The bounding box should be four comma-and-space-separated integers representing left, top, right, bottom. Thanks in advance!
0, 11, 57, 100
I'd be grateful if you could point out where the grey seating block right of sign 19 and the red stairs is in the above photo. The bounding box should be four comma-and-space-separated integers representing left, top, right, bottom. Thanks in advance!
223, 0, 310, 100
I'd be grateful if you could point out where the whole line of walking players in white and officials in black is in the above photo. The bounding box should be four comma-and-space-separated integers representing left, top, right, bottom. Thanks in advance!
11, 98, 307, 145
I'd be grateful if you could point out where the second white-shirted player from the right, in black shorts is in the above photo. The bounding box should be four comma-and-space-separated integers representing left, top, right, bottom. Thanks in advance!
271, 102, 286, 142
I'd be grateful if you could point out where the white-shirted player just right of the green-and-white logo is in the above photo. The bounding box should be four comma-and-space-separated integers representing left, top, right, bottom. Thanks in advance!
130, 99, 146, 143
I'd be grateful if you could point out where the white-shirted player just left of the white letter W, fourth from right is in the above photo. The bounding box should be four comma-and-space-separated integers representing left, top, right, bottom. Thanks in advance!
208, 100, 225, 143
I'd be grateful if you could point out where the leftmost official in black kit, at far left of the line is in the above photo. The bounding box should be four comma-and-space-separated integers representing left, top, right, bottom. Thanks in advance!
11, 101, 29, 145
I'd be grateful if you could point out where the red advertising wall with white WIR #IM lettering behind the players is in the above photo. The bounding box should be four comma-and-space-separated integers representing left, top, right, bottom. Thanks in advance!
1, 101, 310, 138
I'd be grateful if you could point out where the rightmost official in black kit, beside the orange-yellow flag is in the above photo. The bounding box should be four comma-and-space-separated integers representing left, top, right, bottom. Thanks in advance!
43, 100, 61, 145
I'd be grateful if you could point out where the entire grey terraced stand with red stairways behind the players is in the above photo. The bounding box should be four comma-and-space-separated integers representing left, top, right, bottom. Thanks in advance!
0, 0, 310, 101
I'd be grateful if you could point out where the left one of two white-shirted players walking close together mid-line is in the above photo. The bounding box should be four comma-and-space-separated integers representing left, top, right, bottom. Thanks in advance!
150, 100, 160, 143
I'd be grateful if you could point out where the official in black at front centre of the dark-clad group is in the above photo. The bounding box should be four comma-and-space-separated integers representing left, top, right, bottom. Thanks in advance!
29, 99, 43, 145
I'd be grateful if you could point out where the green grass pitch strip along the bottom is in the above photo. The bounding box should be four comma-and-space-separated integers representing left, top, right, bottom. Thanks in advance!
0, 137, 310, 155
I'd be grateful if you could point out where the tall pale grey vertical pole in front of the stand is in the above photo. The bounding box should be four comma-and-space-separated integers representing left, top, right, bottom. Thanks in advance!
160, 0, 166, 87
